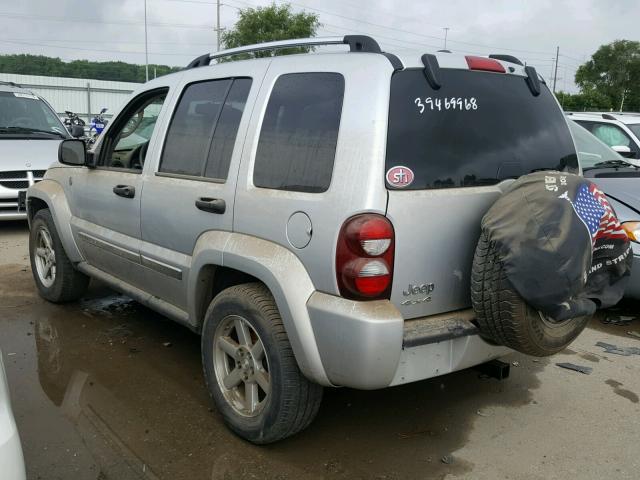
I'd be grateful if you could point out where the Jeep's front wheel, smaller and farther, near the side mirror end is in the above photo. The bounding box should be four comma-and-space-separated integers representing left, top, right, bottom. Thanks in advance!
29, 209, 89, 303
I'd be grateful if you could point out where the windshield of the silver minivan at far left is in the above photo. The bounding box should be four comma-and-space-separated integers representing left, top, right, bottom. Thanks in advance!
0, 92, 67, 139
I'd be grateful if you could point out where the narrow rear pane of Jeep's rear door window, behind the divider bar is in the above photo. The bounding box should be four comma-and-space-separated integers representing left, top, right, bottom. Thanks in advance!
204, 78, 251, 180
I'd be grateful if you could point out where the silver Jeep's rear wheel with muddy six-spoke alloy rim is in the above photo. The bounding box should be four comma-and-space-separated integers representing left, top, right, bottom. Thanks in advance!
202, 283, 322, 444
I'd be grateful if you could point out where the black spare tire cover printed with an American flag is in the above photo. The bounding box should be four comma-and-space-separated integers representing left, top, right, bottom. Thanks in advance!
482, 171, 633, 321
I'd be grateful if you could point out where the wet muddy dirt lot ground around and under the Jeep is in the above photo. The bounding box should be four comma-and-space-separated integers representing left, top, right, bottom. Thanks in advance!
0, 223, 640, 480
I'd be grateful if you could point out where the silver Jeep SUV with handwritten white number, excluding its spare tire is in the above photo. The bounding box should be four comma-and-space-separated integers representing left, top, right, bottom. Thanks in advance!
28, 36, 578, 443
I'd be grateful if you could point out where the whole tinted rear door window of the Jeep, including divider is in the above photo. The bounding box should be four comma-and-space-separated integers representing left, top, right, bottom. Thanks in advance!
160, 78, 251, 180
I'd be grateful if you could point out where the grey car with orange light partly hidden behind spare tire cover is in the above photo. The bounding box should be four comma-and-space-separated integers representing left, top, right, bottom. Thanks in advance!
569, 120, 640, 299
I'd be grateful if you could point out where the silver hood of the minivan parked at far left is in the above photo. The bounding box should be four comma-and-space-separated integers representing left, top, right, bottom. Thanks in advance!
0, 139, 61, 171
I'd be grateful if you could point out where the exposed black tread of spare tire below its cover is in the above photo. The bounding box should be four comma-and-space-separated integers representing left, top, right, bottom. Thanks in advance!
471, 232, 590, 357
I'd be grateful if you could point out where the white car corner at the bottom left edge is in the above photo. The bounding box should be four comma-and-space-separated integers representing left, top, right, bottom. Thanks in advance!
0, 352, 27, 480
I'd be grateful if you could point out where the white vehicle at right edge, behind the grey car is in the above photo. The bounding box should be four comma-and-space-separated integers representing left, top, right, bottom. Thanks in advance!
567, 112, 640, 159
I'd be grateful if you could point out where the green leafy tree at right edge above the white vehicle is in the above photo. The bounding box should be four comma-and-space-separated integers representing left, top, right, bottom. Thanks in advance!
576, 40, 640, 110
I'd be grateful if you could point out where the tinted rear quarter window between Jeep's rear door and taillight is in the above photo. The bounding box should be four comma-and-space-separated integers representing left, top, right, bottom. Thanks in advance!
253, 73, 344, 193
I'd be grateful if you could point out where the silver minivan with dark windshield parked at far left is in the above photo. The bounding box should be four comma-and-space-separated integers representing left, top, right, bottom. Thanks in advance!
0, 82, 71, 221
